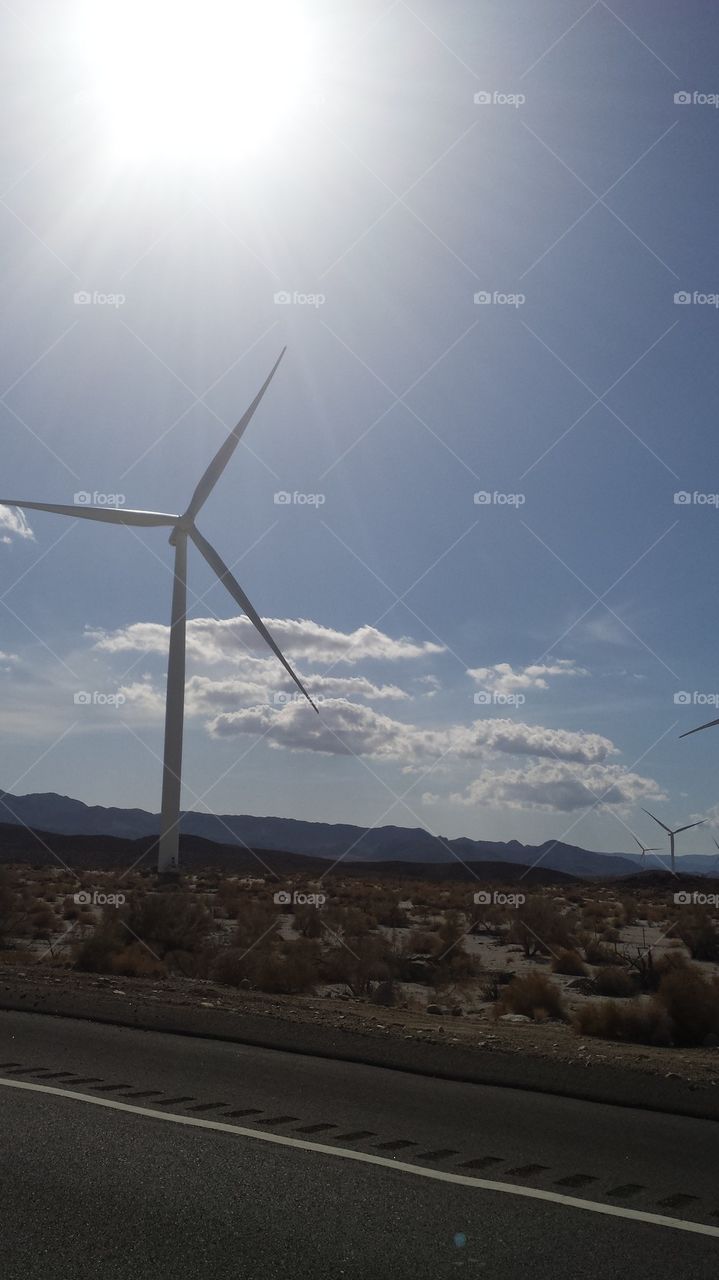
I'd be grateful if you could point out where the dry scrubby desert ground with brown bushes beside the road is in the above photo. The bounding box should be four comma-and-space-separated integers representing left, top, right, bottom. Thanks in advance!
0, 865, 719, 1083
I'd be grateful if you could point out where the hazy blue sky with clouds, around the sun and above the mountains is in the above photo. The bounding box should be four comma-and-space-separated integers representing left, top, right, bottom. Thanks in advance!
0, 0, 719, 851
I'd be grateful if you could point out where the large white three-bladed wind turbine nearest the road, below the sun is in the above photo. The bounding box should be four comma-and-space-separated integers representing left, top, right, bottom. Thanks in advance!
0, 347, 319, 874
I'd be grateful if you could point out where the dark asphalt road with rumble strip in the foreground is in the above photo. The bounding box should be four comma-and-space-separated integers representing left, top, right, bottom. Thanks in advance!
0, 1012, 719, 1280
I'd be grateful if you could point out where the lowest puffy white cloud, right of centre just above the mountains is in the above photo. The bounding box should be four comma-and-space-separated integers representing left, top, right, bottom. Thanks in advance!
423, 760, 667, 813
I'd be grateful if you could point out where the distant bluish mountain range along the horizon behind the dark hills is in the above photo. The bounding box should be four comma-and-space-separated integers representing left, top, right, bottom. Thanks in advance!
0, 791, 719, 877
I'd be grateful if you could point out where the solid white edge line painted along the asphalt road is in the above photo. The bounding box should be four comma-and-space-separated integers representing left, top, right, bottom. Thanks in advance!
0, 1076, 719, 1236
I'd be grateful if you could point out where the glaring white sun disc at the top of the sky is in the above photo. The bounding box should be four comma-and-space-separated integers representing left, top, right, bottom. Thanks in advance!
79, 0, 313, 163
